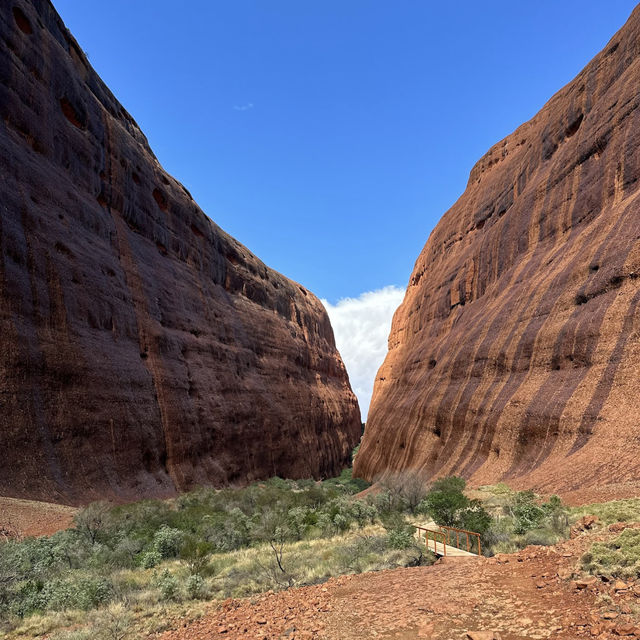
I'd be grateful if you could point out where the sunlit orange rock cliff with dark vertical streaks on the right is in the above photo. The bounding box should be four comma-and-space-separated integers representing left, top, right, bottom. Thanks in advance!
355, 9, 640, 491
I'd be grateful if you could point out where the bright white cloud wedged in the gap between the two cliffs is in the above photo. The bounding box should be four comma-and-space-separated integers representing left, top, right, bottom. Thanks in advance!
322, 285, 404, 420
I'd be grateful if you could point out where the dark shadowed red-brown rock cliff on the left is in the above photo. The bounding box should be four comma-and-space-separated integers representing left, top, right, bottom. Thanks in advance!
0, 0, 360, 501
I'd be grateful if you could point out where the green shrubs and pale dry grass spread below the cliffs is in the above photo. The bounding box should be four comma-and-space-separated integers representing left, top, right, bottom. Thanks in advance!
5, 470, 640, 640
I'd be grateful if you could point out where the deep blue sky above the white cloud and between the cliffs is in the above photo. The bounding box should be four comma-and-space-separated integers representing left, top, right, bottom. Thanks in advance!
53, 0, 635, 418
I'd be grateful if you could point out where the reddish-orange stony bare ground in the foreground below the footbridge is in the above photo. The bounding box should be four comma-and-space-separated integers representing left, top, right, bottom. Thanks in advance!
161, 531, 640, 640
